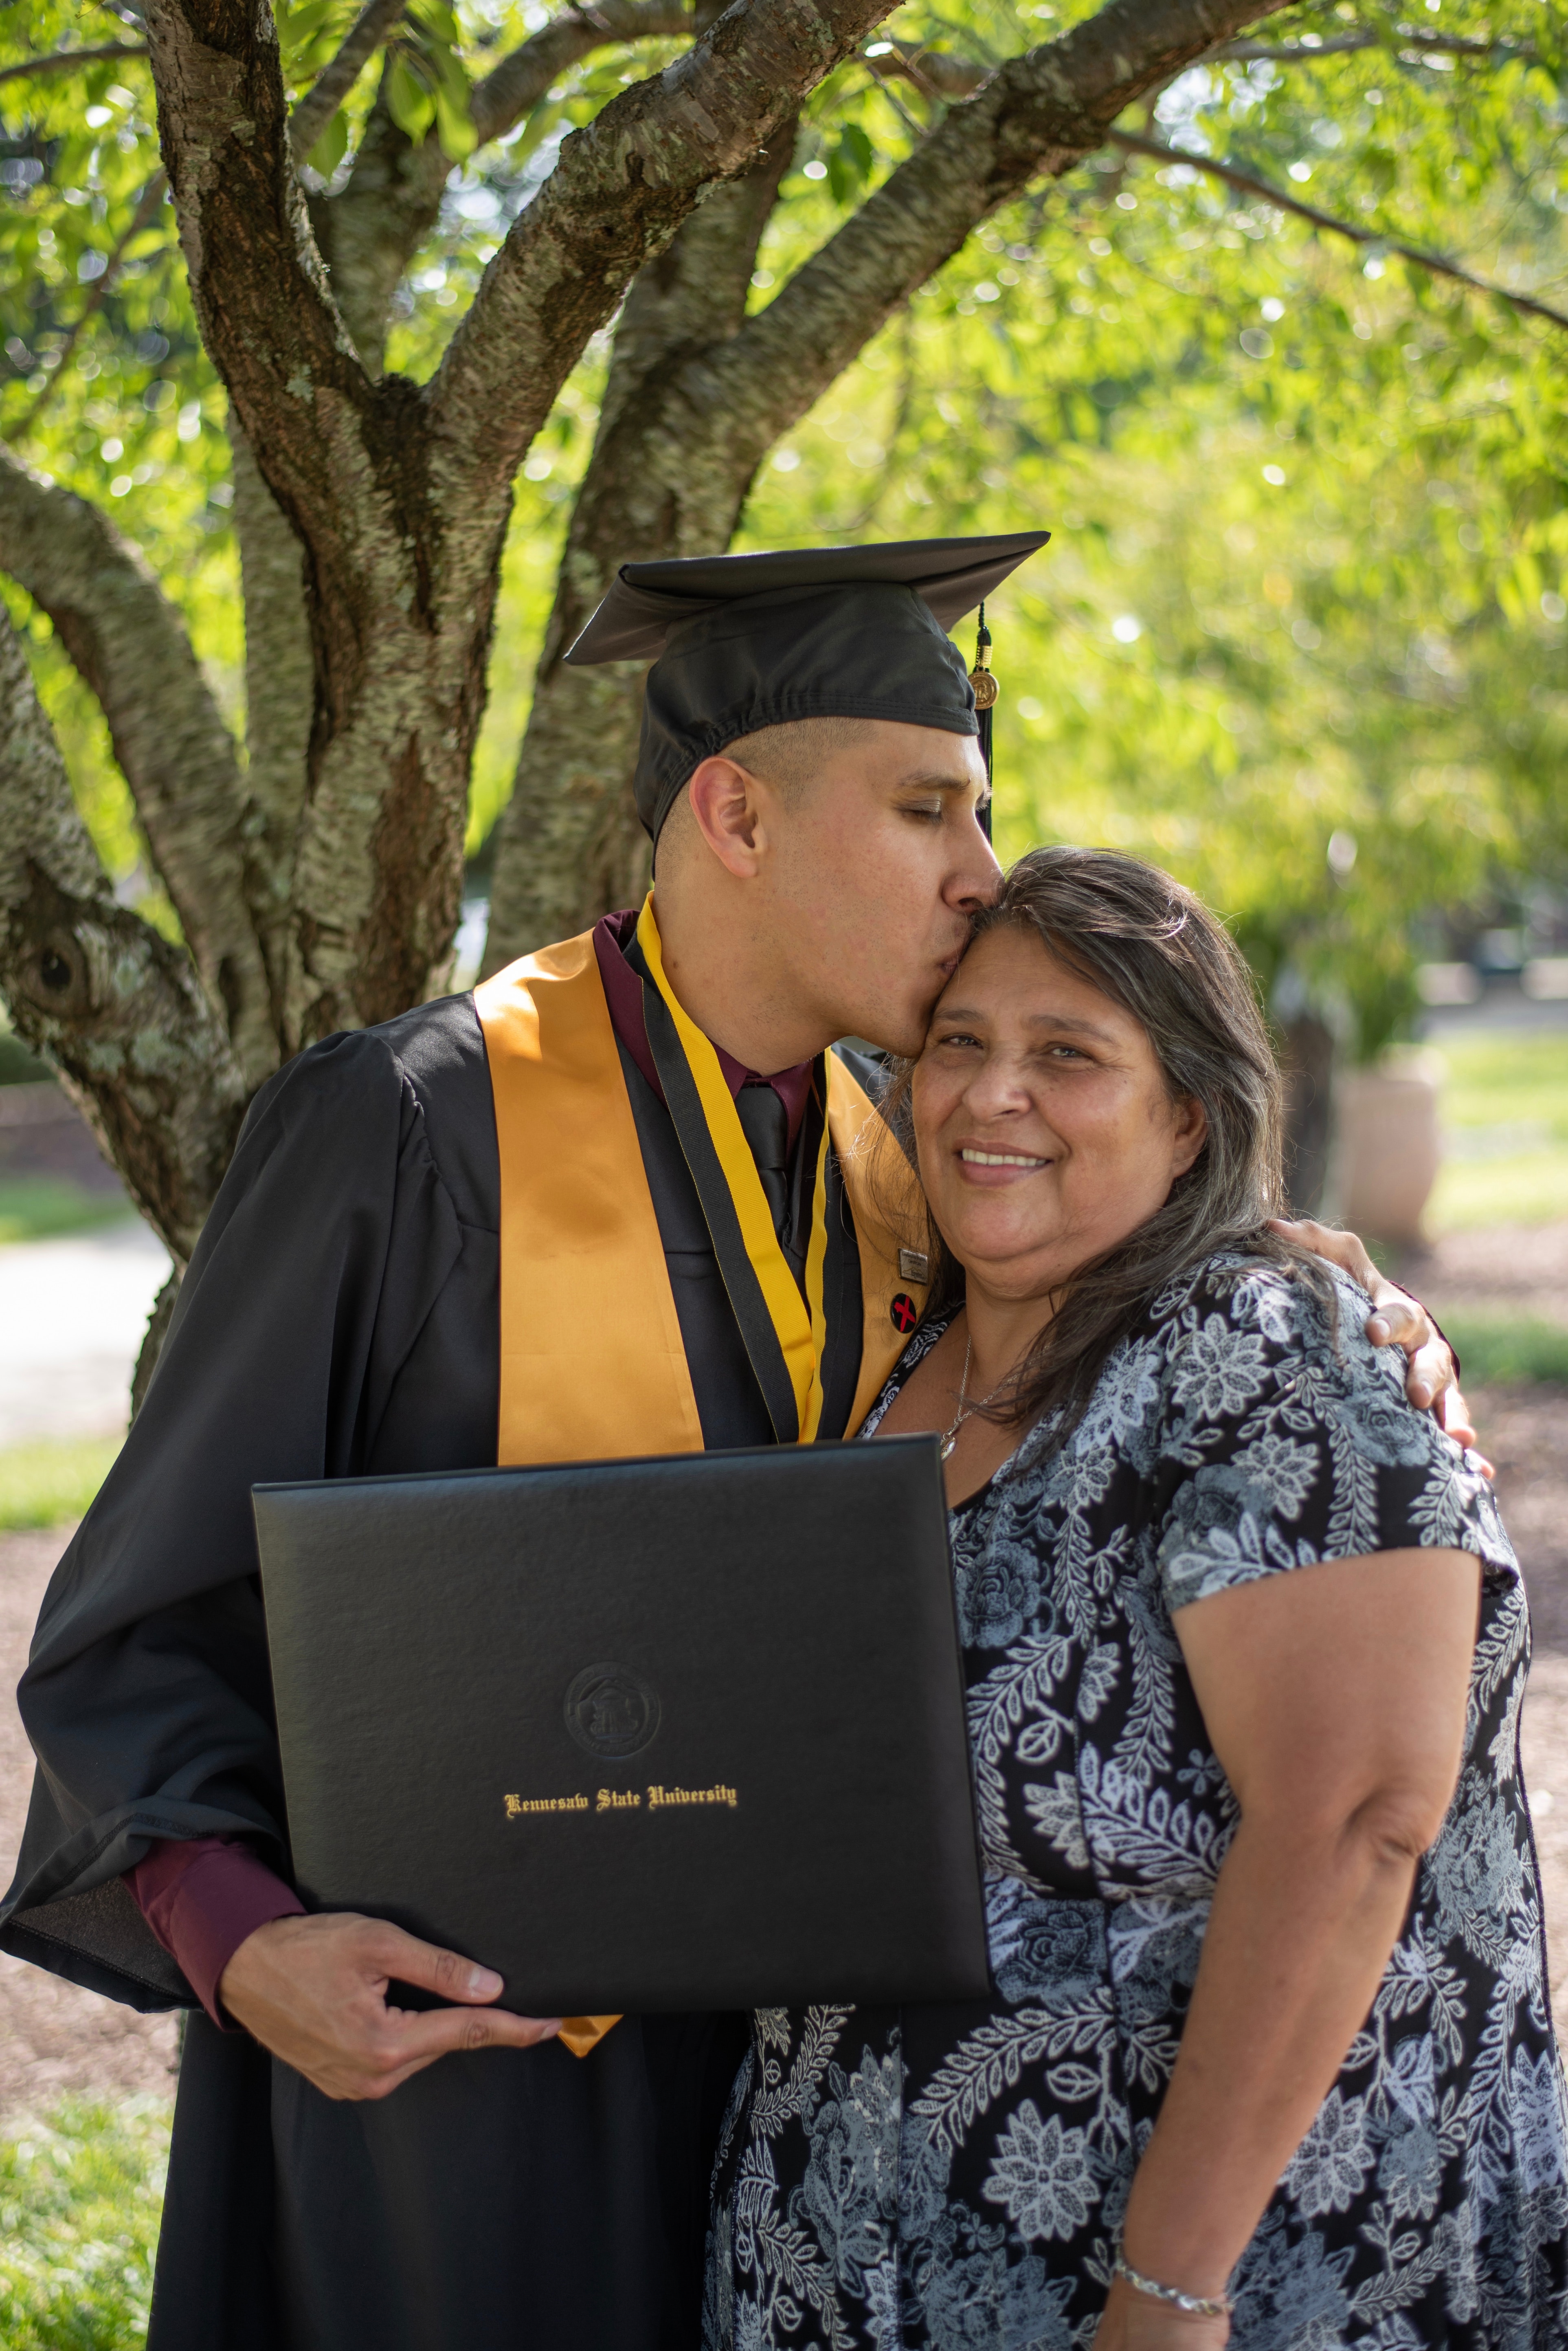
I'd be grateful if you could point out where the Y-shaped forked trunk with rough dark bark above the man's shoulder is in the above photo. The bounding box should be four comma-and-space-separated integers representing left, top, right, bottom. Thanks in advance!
148, 0, 903, 1051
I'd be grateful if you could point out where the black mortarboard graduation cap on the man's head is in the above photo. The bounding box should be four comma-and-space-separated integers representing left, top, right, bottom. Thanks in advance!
567, 531, 1051, 839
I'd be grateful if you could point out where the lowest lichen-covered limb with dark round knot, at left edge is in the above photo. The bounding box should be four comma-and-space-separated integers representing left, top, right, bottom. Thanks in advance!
0, 614, 247, 1262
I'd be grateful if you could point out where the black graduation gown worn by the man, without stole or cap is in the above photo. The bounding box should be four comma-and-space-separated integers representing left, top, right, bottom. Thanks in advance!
0, 997, 861, 2351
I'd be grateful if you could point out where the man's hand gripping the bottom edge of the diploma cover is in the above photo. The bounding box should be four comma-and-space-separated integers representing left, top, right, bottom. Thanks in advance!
219, 1911, 560, 2097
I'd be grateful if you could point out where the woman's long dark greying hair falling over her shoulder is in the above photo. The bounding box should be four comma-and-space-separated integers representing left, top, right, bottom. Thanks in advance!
882, 849, 1335, 1443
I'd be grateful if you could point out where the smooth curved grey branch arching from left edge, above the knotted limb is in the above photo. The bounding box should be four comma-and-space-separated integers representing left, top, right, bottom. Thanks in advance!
0, 442, 277, 1084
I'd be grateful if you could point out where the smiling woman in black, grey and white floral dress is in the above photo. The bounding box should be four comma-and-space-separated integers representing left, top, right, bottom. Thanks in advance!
705, 851, 1568, 2351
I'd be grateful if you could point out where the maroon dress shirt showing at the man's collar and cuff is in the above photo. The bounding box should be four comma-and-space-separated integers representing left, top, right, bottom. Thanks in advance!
125, 912, 813, 2031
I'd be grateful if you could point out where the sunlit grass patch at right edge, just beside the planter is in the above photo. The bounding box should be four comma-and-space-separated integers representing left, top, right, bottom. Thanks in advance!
1427, 1027, 1568, 1232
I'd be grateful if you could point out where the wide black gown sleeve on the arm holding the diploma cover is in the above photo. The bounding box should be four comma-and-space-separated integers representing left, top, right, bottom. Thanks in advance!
0, 1034, 461, 2008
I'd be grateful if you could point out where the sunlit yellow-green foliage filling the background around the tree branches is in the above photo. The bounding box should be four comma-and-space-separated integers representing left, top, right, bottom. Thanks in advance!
0, 0, 1568, 1051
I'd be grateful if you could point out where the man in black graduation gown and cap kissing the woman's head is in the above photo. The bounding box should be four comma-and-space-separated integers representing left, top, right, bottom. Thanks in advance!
0, 534, 1457, 2351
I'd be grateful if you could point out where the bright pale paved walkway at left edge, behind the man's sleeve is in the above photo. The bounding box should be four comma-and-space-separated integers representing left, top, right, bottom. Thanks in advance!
0, 1216, 169, 1451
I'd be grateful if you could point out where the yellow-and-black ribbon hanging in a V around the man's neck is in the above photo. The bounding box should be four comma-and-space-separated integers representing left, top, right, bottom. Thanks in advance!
637, 891, 828, 1446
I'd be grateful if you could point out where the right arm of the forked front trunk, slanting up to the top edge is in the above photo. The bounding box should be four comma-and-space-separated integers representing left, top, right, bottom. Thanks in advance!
430, 0, 907, 529
